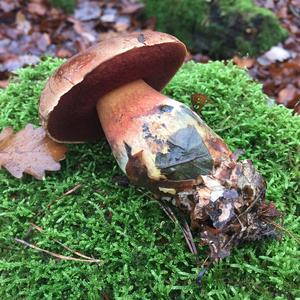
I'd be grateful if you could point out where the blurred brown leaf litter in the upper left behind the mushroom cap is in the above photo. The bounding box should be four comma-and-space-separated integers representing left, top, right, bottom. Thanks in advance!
0, 0, 143, 83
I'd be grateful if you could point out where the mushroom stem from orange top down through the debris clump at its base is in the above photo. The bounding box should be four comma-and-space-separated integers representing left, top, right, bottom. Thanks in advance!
97, 80, 277, 260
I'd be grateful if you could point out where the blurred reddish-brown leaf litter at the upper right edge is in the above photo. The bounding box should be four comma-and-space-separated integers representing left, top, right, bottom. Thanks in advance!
238, 0, 300, 114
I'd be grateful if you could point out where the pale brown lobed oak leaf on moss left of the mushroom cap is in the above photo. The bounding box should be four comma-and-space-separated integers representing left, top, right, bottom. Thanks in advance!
0, 124, 67, 179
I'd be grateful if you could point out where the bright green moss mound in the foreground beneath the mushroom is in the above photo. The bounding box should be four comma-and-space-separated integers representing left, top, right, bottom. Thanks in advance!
0, 59, 300, 299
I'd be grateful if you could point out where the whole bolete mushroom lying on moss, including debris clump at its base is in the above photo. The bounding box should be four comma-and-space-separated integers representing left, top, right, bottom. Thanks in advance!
39, 31, 280, 259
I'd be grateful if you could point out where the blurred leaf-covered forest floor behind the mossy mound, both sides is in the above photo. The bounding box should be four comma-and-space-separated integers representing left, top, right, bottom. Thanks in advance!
0, 0, 300, 113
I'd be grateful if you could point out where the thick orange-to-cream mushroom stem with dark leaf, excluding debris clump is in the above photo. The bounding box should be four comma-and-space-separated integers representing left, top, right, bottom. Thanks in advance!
97, 80, 230, 190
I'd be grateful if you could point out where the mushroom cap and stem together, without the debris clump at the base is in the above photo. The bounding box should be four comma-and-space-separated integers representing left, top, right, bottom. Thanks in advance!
40, 32, 230, 195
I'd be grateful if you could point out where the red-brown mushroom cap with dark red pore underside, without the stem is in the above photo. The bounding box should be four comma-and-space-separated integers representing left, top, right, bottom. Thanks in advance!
39, 31, 186, 143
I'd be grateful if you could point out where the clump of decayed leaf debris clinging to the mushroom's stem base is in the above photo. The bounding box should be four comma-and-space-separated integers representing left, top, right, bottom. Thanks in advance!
163, 151, 281, 262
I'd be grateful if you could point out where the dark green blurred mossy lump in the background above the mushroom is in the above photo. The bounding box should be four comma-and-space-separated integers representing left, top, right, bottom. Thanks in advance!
145, 0, 287, 58
